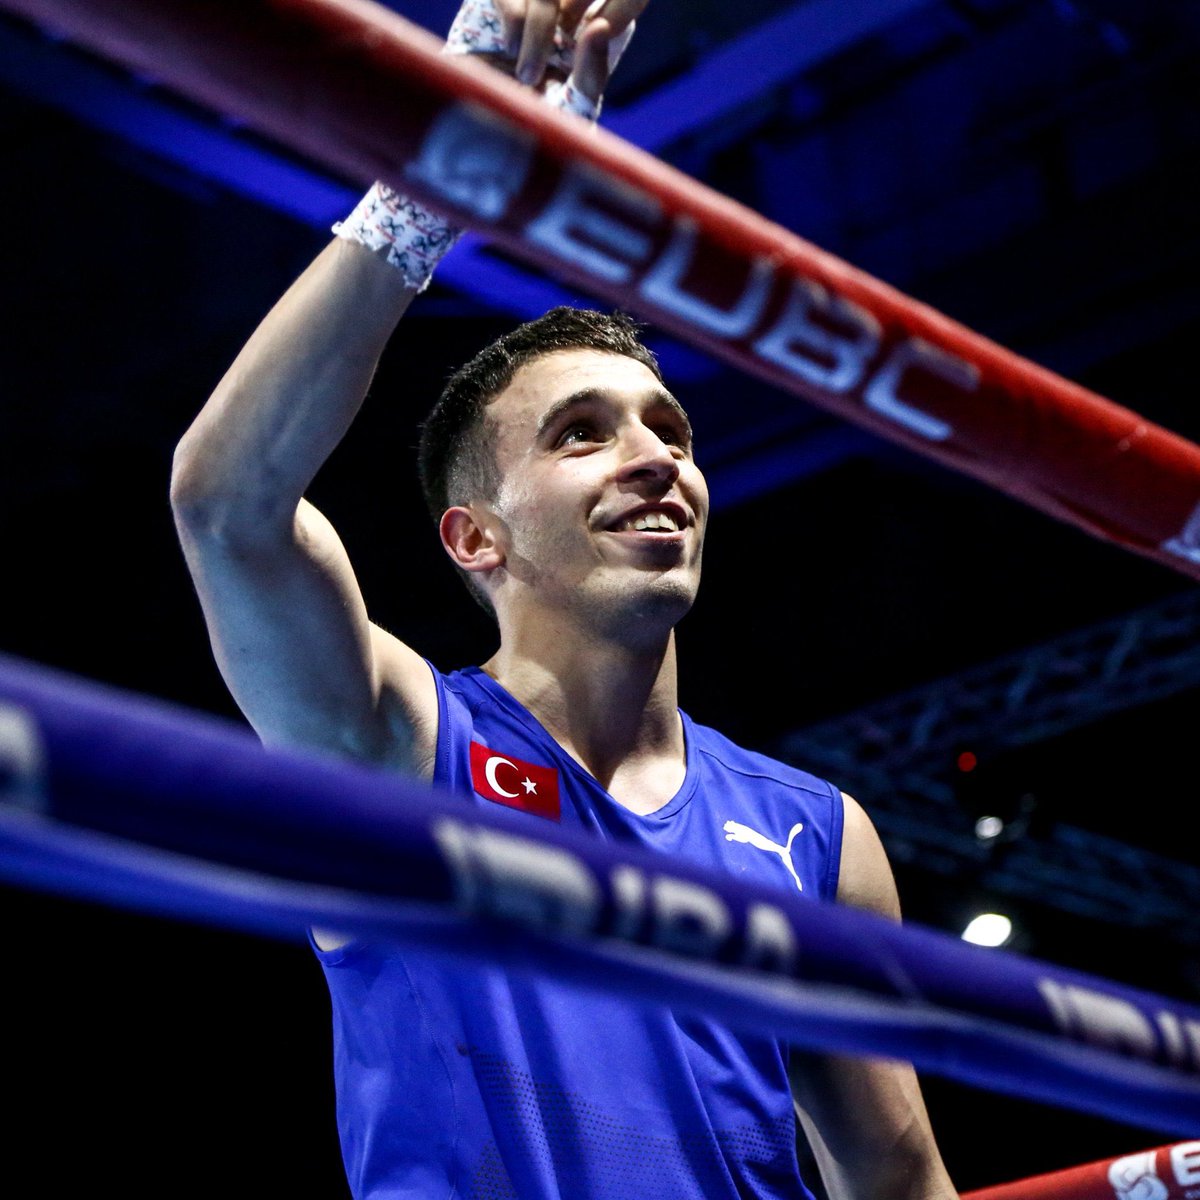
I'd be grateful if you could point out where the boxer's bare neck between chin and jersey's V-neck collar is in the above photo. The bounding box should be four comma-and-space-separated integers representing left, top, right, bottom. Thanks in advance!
484, 609, 684, 791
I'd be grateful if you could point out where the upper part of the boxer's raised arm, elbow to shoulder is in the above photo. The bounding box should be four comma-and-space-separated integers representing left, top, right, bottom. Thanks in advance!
180, 500, 436, 766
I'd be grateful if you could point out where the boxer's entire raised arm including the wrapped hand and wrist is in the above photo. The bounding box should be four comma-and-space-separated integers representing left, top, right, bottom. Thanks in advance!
172, 0, 646, 774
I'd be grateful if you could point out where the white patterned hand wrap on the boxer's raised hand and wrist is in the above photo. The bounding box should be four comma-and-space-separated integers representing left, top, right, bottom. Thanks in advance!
332, 0, 634, 292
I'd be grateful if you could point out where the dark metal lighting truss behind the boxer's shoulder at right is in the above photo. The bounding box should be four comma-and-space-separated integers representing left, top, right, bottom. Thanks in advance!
775, 592, 1200, 947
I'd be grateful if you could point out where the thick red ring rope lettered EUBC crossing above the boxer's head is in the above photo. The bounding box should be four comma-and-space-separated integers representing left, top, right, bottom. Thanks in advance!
9, 0, 1200, 577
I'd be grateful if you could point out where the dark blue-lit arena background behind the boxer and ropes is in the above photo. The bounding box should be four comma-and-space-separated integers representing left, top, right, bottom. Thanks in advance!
0, 0, 1200, 1198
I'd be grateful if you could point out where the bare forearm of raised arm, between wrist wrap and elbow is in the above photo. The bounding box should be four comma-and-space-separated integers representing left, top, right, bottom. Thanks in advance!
172, 239, 416, 533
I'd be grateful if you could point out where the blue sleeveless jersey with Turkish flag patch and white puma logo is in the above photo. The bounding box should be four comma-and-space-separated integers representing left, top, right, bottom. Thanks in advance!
314, 668, 842, 1200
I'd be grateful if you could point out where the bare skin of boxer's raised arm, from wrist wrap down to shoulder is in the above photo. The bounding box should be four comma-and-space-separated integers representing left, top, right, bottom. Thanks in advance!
172, 239, 432, 766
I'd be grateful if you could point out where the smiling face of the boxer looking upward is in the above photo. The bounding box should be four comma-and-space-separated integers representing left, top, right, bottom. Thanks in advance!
472, 350, 708, 637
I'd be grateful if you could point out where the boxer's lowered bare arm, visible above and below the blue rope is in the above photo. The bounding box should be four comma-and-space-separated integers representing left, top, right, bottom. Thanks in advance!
791, 796, 956, 1200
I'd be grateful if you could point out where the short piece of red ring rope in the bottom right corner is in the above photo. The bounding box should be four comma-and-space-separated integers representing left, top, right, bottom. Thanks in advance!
962, 1141, 1200, 1200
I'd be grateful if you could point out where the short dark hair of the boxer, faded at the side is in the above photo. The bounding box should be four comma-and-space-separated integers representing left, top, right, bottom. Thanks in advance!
418, 305, 664, 612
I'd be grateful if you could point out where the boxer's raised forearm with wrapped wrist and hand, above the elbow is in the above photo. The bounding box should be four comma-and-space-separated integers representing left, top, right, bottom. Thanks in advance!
172, 0, 646, 540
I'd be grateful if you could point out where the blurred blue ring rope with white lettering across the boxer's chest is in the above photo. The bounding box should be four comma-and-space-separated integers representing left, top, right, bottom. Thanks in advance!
0, 656, 1200, 1136
